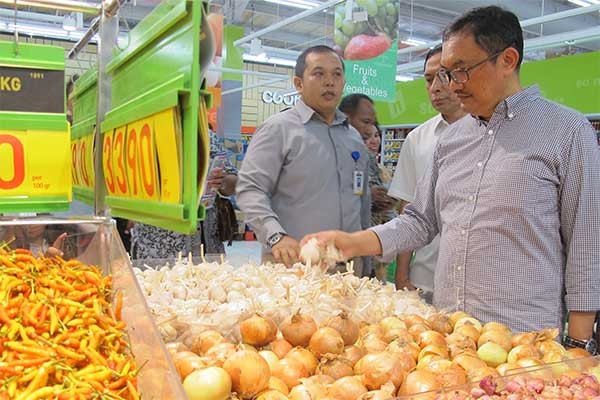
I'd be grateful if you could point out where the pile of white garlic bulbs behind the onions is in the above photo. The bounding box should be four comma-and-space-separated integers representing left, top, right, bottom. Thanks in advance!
134, 259, 434, 342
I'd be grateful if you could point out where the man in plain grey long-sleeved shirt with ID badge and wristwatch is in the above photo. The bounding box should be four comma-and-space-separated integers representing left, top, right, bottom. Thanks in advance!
237, 46, 371, 276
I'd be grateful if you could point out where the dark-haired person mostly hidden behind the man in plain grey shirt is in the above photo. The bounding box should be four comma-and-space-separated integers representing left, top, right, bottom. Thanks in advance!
339, 93, 395, 220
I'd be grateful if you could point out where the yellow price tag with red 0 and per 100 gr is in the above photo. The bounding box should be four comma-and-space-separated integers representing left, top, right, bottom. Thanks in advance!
0, 130, 71, 200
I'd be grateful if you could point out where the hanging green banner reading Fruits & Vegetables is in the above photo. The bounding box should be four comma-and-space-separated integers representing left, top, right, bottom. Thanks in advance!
334, 0, 400, 102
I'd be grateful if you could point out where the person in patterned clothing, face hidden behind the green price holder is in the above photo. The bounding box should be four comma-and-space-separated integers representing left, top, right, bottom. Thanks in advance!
131, 127, 238, 259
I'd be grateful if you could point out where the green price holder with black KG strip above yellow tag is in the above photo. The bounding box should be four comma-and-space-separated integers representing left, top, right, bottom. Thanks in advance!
0, 42, 72, 213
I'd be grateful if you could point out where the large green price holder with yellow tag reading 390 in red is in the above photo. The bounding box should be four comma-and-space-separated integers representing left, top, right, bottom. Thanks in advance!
100, 0, 211, 233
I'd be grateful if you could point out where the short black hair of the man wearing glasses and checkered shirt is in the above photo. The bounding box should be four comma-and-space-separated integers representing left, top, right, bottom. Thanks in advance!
442, 6, 523, 70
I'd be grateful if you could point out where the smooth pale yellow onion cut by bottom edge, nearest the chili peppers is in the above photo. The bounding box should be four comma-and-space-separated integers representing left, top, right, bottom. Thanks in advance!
183, 367, 231, 400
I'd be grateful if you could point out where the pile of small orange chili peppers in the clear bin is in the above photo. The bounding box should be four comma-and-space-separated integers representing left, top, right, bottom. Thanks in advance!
0, 249, 139, 400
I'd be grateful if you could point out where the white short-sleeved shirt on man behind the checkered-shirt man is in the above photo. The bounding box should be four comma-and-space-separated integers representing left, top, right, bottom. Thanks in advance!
388, 114, 449, 292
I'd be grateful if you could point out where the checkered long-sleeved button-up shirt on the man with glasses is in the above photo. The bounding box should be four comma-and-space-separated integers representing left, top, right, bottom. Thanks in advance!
371, 86, 600, 332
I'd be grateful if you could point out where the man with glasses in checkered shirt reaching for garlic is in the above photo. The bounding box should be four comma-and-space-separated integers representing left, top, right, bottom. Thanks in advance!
303, 6, 600, 346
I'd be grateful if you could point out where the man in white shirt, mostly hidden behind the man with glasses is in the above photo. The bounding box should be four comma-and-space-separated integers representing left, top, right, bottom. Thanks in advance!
388, 44, 466, 303
